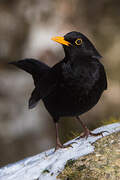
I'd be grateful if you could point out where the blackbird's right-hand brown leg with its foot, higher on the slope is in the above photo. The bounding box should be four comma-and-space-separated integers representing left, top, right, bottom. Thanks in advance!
76, 116, 108, 139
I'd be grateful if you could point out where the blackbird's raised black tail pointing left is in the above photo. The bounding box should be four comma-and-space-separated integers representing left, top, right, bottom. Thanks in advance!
9, 59, 50, 86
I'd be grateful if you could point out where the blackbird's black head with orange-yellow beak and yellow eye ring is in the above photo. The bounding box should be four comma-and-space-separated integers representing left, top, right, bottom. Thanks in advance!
52, 31, 102, 59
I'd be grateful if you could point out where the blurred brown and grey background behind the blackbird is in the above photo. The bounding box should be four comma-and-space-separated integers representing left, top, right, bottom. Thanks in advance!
0, 0, 120, 167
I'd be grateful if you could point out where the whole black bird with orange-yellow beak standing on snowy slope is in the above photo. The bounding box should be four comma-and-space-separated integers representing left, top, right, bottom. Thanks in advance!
11, 31, 107, 149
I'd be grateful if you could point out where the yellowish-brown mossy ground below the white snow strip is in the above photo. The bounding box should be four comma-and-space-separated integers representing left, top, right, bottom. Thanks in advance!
58, 132, 120, 180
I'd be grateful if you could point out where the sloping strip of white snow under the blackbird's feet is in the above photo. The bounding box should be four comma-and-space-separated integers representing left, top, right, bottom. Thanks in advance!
0, 123, 120, 180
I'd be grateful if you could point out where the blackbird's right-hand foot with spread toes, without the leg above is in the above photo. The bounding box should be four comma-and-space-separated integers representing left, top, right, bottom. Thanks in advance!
77, 129, 109, 139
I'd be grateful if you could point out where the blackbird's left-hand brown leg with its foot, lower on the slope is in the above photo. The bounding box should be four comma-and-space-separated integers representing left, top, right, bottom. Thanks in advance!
55, 122, 73, 151
